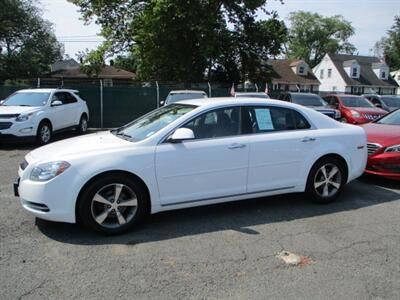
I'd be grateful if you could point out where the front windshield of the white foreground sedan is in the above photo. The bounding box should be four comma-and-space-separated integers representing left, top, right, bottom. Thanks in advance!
111, 104, 196, 142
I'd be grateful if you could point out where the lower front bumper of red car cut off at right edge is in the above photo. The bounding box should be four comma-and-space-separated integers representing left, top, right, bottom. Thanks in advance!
365, 153, 400, 180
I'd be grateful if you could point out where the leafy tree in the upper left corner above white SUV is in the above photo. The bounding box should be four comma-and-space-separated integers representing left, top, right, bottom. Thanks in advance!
0, 0, 62, 81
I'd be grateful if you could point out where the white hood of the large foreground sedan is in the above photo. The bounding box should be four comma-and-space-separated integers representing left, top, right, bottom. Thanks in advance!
27, 131, 133, 162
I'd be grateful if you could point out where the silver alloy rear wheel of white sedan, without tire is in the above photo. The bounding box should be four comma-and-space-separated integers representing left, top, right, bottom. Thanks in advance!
314, 163, 342, 198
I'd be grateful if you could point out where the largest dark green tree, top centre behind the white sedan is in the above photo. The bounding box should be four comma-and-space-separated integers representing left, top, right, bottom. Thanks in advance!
69, 0, 286, 82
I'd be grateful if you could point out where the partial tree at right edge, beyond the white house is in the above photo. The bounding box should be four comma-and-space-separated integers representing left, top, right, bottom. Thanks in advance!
376, 16, 400, 71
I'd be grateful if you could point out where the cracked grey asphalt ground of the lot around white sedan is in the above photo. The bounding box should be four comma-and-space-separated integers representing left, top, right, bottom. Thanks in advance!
0, 134, 400, 299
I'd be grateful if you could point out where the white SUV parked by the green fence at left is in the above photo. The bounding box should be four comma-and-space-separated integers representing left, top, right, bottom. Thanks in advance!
0, 89, 89, 144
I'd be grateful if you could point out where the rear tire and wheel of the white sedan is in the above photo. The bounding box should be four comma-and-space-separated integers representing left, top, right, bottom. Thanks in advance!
306, 157, 346, 203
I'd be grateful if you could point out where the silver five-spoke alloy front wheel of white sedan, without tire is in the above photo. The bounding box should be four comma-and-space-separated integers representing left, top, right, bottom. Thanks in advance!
91, 183, 138, 229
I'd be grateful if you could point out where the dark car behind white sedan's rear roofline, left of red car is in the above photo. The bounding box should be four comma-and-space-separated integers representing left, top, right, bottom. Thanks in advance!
279, 92, 341, 120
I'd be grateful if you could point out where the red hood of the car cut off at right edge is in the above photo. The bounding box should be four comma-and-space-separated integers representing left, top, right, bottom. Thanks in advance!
362, 123, 400, 147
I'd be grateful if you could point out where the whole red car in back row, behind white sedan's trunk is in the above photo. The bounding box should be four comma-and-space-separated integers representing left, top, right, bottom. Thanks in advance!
324, 95, 387, 124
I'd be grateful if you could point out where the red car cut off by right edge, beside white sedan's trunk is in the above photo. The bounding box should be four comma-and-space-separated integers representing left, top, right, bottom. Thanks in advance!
362, 109, 400, 180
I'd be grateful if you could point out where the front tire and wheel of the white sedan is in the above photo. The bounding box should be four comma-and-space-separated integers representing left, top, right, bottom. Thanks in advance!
78, 174, 148, 235
